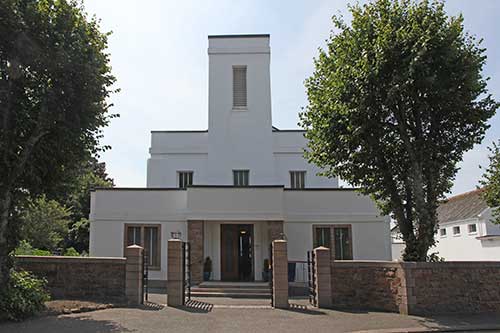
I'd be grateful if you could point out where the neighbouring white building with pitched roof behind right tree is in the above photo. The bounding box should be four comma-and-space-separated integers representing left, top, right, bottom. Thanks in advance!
392, 189, 500, 261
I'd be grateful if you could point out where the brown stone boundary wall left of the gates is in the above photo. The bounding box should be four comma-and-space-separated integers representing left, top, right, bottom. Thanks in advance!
15, 256, 127, 302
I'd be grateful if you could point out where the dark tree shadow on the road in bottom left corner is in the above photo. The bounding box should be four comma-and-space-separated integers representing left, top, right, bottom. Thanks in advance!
0, 316, 132, 333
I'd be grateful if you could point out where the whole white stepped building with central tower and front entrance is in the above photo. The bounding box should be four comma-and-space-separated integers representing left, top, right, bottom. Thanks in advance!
90, 35, 391, 281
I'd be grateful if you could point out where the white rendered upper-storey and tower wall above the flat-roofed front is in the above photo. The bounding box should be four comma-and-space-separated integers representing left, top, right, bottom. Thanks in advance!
147, 36, 338, 187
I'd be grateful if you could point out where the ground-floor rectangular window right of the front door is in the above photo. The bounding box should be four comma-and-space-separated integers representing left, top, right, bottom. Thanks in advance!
313, 225, 352, 260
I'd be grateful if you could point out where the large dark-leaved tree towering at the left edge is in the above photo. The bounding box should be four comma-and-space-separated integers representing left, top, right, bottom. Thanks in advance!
0, 0, 115, 286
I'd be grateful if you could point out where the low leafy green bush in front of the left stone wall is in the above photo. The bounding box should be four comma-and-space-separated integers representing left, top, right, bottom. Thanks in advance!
0, 270, 50, 321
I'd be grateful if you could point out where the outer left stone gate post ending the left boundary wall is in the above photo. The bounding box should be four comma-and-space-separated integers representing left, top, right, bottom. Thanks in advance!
125, 245, 143, 305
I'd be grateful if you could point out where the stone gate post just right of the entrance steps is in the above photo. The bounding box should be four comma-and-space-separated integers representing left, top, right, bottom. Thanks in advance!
272, 240, 289, 309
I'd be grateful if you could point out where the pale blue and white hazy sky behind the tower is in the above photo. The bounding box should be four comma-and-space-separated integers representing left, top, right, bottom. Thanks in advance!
84, 0, 500, 194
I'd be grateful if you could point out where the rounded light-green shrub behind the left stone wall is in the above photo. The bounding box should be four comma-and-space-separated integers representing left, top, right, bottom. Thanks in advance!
21, 195, 70, 251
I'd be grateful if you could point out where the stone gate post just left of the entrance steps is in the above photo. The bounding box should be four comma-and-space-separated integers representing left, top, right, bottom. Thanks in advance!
167, 239, 184, 306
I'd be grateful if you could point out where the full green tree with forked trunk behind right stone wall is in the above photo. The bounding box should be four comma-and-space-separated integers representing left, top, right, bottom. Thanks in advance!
301, 0, 498, 261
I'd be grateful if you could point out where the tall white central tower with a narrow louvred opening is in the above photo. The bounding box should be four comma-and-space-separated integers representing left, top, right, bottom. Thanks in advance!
208, 35, 276, 185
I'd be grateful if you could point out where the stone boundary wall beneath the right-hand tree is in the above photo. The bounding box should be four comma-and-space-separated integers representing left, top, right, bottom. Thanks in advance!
331, 261, 500, 314
